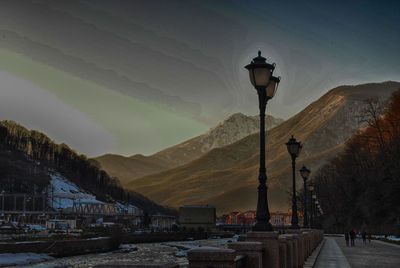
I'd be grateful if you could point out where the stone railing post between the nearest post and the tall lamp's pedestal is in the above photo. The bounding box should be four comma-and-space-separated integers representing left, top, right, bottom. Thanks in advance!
228, 242, 263, 268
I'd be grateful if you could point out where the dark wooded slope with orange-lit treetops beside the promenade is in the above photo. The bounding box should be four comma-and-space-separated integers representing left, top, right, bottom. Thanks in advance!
314, 90, 400, 234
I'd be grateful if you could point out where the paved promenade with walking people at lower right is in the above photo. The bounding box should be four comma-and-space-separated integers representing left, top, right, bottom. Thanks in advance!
314, 237, 400, 268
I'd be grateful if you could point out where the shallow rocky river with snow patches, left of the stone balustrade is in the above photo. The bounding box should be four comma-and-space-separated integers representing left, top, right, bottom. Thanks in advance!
28, 239, 233, 267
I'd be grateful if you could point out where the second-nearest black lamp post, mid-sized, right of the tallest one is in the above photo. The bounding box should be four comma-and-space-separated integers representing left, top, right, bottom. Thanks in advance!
286, 135, 302, 229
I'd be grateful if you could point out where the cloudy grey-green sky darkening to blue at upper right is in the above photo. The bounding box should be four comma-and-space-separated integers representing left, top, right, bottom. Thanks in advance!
0, 0, 400, 157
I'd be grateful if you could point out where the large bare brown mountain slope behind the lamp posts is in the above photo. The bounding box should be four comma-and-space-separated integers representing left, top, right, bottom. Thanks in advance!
128, 82, 400, 214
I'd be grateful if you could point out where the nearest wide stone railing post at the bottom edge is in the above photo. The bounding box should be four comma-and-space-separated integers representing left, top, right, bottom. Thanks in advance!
187, 248, 236, 268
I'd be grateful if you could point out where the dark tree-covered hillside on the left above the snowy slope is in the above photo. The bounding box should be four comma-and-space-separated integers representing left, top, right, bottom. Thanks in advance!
0, 120, 174, 214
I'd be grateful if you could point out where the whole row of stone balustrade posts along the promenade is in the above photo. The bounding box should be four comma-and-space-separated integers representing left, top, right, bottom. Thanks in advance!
188, 229, 323, 268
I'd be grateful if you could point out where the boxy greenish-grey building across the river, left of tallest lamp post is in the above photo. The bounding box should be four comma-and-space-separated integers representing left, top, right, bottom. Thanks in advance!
179, 205, 216, 230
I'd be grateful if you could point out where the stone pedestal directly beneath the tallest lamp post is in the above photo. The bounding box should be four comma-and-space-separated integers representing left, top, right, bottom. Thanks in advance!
247, 232, 279, 268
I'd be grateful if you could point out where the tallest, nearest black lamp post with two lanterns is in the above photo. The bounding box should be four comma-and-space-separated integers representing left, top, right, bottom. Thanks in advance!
245, 51, 280, 231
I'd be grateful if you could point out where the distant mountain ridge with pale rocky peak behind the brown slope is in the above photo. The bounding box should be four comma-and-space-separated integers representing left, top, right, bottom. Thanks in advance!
95, 113, 283, 185
